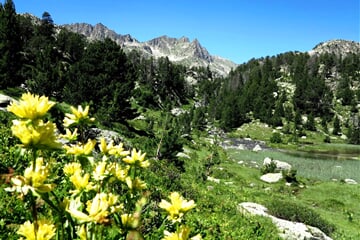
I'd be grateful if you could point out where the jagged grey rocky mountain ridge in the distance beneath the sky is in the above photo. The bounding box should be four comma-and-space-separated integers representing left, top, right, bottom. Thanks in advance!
62, 23, 237, 76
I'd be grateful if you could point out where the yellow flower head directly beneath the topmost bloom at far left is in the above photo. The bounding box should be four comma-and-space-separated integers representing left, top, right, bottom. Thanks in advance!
11, 120, 61, 148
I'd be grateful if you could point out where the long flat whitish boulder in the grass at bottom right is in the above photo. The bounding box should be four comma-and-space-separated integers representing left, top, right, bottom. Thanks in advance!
238, 202, 332, 240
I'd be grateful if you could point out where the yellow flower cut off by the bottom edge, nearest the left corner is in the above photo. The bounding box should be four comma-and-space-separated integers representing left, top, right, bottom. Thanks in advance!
17, 220, 56, 240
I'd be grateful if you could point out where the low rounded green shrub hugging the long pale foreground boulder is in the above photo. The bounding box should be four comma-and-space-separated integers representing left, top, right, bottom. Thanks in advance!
266, 200, 335, 235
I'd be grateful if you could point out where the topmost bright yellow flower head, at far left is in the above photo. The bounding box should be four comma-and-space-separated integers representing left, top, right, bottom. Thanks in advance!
7, 93, 55, 120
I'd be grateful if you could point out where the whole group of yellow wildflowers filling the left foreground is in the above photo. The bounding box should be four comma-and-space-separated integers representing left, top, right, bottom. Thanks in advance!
6, 93, 201, 240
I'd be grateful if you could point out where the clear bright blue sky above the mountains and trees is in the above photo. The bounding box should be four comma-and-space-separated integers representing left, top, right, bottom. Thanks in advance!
6, 0, 360, 63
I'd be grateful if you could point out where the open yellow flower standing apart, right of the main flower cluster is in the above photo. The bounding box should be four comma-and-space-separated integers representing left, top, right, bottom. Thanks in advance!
159, 192, 196, 222
